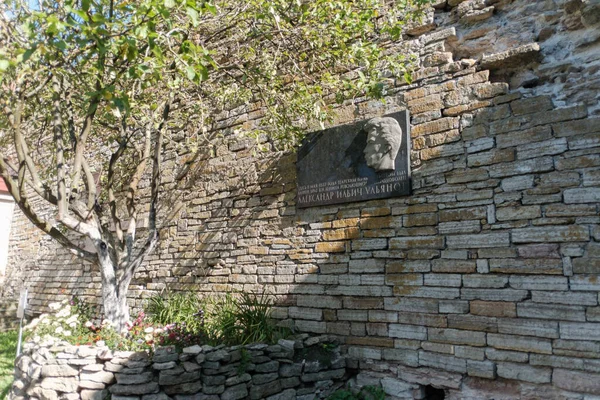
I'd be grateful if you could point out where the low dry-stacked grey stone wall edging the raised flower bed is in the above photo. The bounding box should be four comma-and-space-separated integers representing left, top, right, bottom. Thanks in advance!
9, 335, 347, 400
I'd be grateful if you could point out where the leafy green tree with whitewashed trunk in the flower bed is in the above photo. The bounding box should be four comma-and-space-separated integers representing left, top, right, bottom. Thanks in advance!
0, 0, 430, 329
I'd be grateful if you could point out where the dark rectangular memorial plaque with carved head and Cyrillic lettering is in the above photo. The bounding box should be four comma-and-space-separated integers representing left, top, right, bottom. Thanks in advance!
296, 111, 411, 208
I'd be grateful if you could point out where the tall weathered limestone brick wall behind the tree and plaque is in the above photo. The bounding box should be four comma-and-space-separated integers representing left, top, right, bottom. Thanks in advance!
4, 0, 600, 399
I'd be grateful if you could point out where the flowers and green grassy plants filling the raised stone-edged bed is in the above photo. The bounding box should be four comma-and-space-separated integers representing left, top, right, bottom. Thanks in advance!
28, 292, 289, 351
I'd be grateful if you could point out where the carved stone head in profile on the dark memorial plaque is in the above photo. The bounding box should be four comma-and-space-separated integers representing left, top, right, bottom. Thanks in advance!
363, 117, 402, 171
